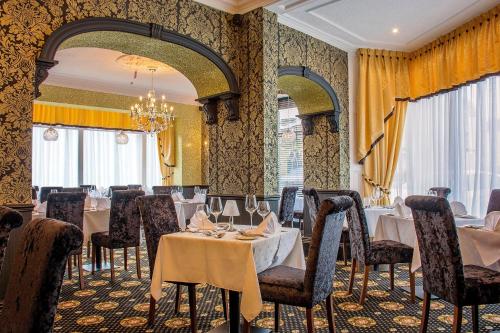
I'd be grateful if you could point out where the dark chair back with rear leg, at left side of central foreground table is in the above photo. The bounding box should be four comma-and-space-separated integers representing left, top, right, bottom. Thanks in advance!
136, 194, 179, 277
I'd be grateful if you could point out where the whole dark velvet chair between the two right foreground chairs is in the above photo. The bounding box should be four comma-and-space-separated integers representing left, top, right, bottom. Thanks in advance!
333, 190, 415, 305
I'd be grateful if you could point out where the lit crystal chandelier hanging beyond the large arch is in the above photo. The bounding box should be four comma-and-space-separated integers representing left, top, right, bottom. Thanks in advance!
130, 67, 174, 134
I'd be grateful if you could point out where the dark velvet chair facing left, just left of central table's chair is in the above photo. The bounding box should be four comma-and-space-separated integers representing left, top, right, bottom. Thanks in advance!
90, 190, 144, 281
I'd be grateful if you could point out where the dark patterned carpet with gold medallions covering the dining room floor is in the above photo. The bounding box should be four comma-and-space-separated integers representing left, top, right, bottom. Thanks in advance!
54, 243, 500, 333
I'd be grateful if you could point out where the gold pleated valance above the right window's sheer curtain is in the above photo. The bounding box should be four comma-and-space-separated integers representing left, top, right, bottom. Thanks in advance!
409, 5, 500, 99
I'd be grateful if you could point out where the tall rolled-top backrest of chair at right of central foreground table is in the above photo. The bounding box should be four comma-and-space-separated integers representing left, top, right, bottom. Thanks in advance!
304, 196, 352, 305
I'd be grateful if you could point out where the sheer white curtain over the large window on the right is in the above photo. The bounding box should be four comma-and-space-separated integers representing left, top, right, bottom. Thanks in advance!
392, 76, 500, 216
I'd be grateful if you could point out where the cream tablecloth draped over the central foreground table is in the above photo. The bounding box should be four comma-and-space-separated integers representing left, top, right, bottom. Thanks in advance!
151, 226, 305, 321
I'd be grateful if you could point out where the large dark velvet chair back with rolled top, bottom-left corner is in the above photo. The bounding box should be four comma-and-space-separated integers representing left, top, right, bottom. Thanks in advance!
0, 219, 83, 333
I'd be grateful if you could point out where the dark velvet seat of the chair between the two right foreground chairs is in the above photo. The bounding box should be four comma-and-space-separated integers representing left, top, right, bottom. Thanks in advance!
367, 240, 413, 265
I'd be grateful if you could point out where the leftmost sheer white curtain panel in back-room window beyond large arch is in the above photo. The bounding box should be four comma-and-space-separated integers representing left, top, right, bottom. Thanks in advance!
32, 126, 78, 187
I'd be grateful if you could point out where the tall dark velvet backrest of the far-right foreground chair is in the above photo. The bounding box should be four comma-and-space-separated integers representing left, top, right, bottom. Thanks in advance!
406, 195, 465, 305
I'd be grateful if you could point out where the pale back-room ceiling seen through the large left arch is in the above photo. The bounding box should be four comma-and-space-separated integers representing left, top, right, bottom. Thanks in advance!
44, 47, 198, 105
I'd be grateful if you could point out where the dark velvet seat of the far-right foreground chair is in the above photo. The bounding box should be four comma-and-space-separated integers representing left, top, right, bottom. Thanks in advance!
464, 265, 500, 305
